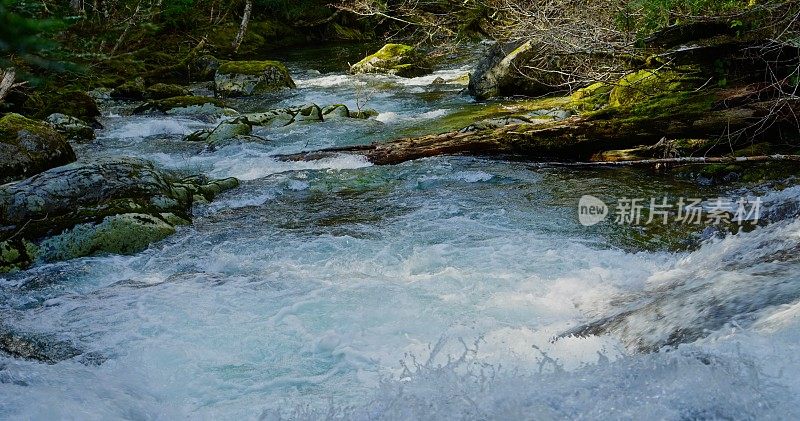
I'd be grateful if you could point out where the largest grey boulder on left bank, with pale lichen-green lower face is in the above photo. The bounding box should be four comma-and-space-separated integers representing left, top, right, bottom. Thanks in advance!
0, 159, 238, 271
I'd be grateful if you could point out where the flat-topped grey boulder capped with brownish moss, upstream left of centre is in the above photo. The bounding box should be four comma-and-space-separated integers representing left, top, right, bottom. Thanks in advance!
214, 61, 295, 97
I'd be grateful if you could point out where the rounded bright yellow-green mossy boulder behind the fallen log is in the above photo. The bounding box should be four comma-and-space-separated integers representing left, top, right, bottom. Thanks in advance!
609, 70, 691, 107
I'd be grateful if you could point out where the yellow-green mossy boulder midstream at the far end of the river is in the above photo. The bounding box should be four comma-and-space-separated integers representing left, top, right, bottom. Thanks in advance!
350, 44, 432, 77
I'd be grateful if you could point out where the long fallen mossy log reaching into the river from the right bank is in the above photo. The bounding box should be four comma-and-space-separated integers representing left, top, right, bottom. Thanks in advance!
284, 94, 800, 165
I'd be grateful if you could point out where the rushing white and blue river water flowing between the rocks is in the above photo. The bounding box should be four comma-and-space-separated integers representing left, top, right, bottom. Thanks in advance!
0, 44, 800, 419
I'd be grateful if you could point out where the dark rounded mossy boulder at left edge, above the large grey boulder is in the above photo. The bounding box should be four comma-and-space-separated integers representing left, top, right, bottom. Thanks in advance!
0, 114, 75, 184
